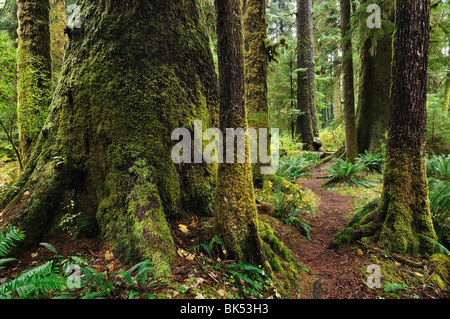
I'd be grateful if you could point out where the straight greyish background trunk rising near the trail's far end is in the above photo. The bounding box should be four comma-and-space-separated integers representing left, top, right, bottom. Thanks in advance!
296, 0, 319, 150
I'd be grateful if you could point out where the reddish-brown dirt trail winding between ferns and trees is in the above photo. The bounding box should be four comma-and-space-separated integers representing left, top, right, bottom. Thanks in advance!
300, 164, 373, 299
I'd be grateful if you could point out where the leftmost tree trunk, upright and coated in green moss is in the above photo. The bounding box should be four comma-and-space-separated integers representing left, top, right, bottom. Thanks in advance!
17, 0, 52, 165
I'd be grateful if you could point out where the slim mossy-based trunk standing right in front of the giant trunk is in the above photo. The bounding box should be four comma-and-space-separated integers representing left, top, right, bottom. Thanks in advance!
214, 0, 265, 265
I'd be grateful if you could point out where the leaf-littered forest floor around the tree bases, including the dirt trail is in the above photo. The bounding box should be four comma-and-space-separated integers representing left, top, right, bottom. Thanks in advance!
0, 164, 450, 299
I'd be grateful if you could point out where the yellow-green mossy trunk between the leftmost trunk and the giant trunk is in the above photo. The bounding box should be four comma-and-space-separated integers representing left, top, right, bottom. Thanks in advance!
50, 0, 69, 79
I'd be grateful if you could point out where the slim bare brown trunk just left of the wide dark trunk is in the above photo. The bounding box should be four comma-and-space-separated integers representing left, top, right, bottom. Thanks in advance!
340, 0, 358, 161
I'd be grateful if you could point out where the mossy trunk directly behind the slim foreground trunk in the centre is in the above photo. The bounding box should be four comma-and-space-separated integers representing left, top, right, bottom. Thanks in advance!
243, 0, 270, 184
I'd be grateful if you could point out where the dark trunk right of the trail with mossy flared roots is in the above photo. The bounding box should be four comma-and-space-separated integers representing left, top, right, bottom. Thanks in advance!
335, 0, 435, 255
